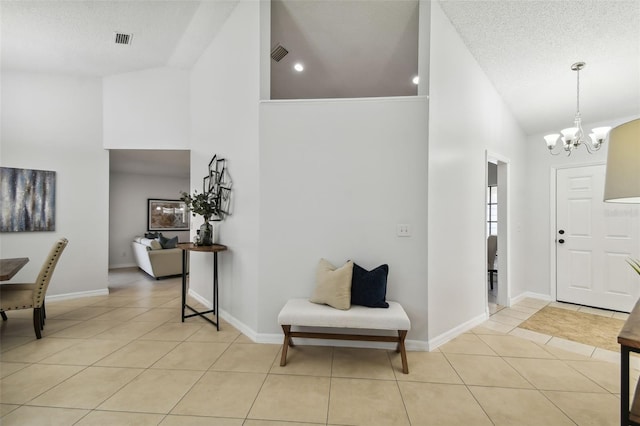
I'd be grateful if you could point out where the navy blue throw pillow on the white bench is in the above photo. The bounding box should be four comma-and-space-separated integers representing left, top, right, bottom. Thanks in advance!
351, 263, 389, 308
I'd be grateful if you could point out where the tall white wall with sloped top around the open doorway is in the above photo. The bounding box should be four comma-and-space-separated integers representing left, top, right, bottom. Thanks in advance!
428, 2, 530, 345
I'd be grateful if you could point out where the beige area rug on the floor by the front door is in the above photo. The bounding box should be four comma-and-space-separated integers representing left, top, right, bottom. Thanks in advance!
519, 306, 624, 352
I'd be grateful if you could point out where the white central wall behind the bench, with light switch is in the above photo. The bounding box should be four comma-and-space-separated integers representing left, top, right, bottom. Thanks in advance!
258, 97, 428, 341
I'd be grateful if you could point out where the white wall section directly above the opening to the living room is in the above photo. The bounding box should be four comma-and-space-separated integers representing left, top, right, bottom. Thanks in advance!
103, 67, 190, 149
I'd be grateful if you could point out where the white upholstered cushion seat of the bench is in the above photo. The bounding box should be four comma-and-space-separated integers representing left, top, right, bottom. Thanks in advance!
278, 299, 411, 330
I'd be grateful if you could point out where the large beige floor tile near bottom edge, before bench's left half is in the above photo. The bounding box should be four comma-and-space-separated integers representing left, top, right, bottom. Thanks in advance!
247, 375, 330, 423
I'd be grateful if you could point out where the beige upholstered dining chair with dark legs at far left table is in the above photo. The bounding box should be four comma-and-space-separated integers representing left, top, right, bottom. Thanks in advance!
0, 238, 69, 339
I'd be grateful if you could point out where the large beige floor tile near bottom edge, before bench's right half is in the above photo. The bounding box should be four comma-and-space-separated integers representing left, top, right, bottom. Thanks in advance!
328, 378, 409, 426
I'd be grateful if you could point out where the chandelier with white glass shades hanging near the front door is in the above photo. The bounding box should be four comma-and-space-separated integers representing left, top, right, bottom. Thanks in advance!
544, 62, 611, 155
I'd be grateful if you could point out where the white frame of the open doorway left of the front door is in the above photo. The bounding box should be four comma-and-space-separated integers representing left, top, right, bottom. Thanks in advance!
484, 150, 511, 311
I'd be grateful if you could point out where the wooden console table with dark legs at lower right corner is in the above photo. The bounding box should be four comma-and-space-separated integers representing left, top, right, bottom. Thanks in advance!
618, 300, 640, 426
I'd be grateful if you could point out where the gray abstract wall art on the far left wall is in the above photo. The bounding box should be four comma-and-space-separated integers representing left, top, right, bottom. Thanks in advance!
0, 167, 56, 232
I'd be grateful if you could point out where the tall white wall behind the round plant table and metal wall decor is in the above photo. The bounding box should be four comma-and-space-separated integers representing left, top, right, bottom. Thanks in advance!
190, 1, 260, 331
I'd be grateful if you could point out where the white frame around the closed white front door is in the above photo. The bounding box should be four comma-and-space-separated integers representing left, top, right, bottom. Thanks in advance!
549, 161, 607, 302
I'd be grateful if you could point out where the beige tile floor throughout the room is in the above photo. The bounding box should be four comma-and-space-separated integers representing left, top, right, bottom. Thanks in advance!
0, 269, 638, 426
